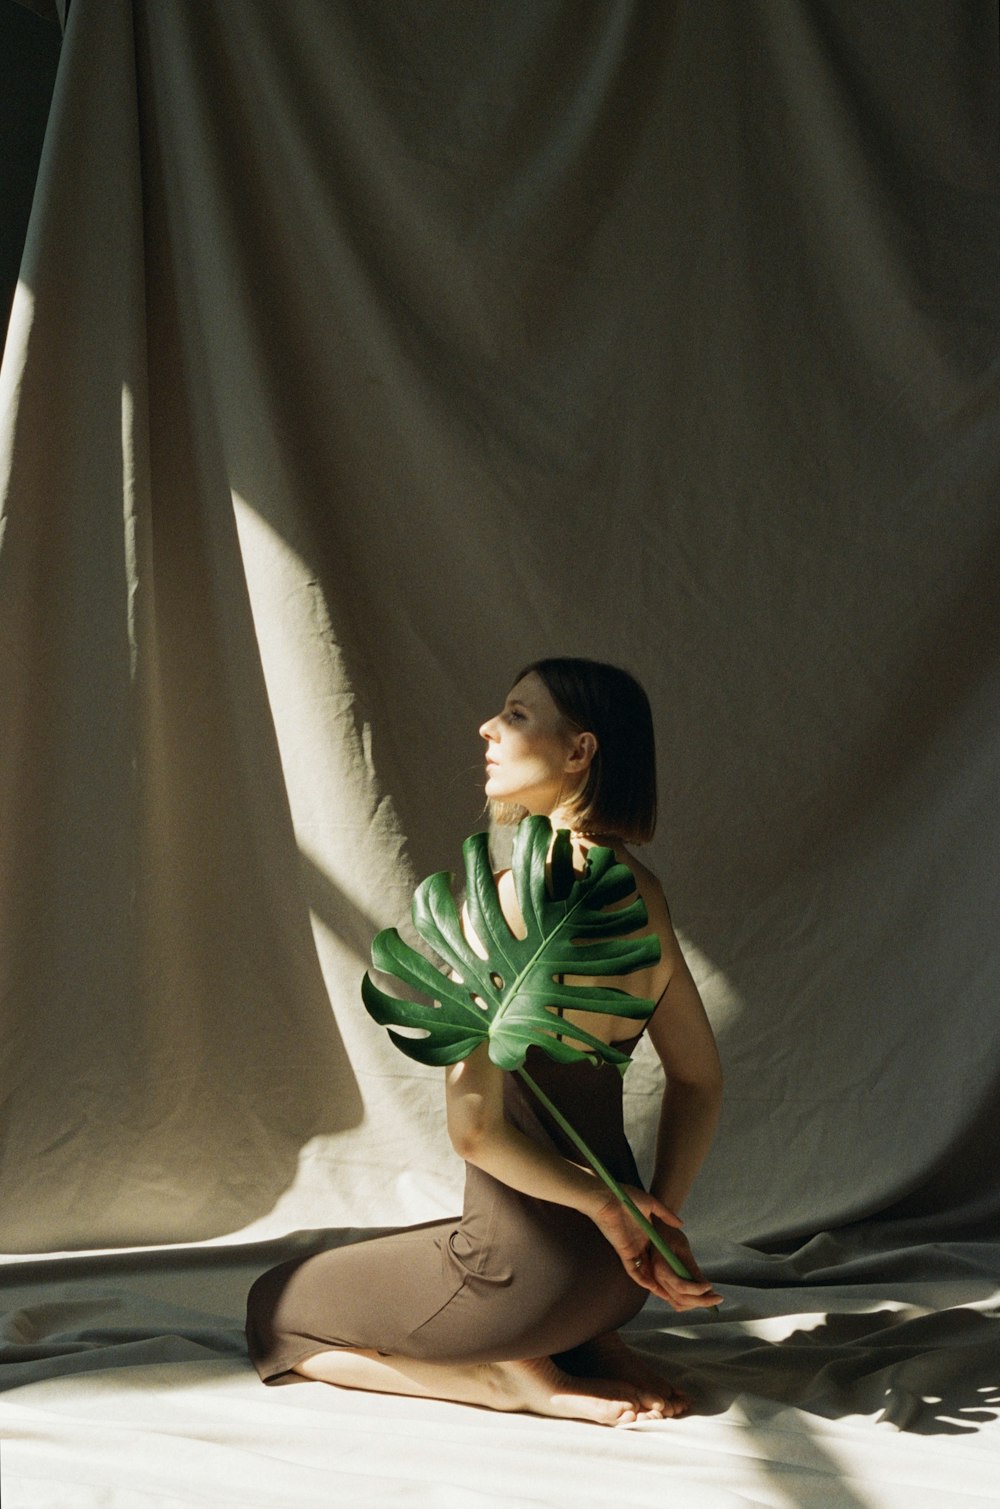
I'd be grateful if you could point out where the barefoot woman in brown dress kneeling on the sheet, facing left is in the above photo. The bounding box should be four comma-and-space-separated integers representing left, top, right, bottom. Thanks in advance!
247, 659, 721, 1424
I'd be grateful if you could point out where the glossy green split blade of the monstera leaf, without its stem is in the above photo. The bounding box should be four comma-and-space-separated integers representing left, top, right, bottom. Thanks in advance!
362, 816, 659, 1070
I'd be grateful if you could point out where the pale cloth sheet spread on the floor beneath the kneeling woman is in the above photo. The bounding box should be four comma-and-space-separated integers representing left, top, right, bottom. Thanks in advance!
0, 1233, 1000, 1509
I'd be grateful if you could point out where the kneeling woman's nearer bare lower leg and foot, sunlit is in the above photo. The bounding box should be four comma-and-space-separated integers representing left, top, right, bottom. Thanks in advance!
296, 1348, 676, 1426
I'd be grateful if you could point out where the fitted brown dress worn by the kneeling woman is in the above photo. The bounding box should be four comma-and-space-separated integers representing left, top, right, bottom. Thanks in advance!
247, 1037, 646, 1384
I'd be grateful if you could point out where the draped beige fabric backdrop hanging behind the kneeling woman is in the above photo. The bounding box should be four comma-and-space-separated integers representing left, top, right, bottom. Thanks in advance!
0, 0, 1000, 1252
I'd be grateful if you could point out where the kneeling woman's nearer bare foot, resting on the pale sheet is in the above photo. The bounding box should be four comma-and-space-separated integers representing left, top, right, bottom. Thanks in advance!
489, 1357, 665, 1426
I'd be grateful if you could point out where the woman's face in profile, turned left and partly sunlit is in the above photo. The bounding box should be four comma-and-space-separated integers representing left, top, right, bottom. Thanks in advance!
480, 672, 591, 815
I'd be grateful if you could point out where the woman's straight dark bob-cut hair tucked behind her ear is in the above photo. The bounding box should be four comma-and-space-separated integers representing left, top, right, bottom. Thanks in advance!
514, 656, 656, 844
